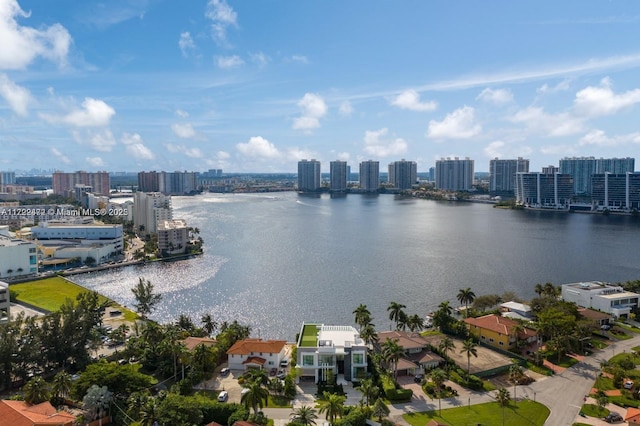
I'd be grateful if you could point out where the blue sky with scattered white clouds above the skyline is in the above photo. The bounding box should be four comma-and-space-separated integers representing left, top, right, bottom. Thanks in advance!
0, 0, 640, 172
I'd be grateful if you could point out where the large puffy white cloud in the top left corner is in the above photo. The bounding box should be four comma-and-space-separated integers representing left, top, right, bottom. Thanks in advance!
0, 0, 71, 69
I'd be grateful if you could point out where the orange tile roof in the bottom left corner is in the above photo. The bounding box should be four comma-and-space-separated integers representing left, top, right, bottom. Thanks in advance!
0, 400, 76, 426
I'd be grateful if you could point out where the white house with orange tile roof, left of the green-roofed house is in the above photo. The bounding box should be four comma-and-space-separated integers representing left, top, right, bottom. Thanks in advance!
227, 339, 287, 371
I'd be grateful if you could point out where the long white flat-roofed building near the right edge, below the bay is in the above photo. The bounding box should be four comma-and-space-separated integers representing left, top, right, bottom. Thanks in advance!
562, 281, 640, 318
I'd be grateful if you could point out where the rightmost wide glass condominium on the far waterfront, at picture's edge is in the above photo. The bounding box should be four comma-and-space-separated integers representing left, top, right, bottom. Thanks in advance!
591, 173, 640, 211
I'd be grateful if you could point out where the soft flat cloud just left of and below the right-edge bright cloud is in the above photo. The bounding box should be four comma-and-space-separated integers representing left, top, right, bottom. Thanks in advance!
510, 107, 584, 136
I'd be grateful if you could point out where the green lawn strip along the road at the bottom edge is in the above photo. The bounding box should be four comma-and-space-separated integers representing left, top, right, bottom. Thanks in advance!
402, 401, 550, 426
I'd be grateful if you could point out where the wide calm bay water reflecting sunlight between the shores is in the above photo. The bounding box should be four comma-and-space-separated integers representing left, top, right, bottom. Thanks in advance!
73, 192, 640, 340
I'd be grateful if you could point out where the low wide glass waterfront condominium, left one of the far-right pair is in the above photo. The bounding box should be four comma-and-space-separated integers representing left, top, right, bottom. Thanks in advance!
516, 172, 573, 209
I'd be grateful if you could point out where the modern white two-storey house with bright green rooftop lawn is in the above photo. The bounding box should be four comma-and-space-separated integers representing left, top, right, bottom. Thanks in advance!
297, 323, 367, 383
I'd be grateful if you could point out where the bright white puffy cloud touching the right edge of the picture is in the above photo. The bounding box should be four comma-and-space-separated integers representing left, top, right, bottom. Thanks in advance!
574, 78, 640, 117
